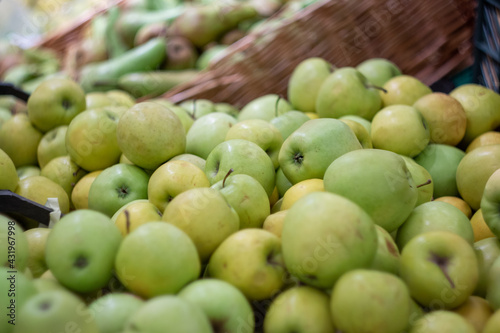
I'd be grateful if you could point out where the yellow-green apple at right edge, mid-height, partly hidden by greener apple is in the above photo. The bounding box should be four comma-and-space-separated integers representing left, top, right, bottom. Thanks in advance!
457, 144, 500, 210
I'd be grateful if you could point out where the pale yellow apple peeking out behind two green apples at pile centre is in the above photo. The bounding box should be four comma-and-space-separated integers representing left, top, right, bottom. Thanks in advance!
225, 119, 283, 168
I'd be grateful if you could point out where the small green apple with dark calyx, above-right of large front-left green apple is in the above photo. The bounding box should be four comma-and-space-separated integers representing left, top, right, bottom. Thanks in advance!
89, 163, 149, 217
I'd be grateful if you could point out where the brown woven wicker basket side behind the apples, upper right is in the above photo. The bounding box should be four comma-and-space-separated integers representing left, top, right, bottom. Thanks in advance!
163, 0, 475, 107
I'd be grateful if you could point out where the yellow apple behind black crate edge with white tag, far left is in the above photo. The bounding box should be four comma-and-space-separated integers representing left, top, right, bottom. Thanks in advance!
16, 176, 69, 214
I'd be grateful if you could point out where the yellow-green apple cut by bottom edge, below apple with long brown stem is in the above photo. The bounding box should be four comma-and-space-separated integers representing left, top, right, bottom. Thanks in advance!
409, 310, 477, 333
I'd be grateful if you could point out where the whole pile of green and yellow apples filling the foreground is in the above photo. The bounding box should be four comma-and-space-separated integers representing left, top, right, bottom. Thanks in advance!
0, 58, 500, 333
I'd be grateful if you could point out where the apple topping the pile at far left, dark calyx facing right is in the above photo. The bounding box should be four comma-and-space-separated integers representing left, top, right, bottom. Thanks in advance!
28, 78, 86, 132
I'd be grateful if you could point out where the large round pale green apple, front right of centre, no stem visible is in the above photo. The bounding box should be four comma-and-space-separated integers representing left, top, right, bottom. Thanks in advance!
281, 192, 377, 288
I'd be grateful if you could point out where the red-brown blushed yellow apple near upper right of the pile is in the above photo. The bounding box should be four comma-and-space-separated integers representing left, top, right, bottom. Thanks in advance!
413, 92, 467, 146
